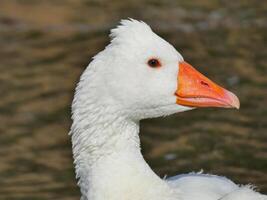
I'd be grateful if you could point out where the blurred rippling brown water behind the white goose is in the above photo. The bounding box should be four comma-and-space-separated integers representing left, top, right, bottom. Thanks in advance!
0, 0, 267, 200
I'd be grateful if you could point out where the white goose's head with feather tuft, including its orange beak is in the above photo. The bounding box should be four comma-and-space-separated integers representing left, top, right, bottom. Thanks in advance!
86, 19, 239, 120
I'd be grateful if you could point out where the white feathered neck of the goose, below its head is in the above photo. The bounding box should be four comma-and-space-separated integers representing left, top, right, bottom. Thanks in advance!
71, 104, 180, 200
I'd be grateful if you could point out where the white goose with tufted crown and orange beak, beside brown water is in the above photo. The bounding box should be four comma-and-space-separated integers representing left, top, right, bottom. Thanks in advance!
71, 19, 267, 200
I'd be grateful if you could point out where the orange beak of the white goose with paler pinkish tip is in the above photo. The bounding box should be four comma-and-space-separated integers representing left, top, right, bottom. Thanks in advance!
175, 62, 240, 109
